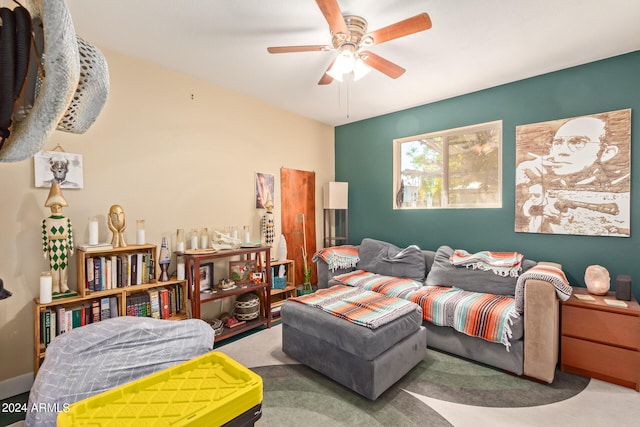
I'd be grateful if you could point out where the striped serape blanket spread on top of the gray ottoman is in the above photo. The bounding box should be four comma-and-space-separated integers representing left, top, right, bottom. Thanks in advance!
289, 285, 420, 329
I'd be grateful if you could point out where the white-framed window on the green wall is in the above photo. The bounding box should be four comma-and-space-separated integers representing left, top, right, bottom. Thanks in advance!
393, 121, 502, 209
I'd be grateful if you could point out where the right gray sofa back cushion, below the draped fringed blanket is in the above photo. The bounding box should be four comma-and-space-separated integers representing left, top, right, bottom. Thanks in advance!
426, 246, 536, 296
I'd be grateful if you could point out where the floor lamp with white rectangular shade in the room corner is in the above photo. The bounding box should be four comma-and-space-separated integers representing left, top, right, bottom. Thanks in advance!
323, 182, 349, 248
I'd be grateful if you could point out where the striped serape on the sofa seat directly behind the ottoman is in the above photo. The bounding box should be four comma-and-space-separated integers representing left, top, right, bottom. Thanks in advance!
333, 270, 422, 300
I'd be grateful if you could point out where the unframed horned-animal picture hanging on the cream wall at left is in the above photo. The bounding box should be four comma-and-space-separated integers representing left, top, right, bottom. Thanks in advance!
33, 151, 84, 188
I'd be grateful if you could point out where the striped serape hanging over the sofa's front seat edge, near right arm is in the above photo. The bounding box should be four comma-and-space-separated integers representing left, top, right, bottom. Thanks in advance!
410, 286, 519, 351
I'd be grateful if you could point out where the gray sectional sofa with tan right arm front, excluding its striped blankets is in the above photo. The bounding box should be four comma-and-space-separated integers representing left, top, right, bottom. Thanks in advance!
314, 239, 560, 383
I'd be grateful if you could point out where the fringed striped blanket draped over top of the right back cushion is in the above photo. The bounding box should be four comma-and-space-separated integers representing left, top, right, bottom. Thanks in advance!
449, 249, 523, 277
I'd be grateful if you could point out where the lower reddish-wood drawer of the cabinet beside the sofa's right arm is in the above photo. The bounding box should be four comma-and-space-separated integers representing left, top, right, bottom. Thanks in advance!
561, 336, 640, 390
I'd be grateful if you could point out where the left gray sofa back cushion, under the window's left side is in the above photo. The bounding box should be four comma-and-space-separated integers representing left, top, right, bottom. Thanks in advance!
356, 238, 426, 282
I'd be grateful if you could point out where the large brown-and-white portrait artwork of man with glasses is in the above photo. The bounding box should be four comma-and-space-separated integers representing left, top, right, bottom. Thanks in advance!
515, 109, 631, 237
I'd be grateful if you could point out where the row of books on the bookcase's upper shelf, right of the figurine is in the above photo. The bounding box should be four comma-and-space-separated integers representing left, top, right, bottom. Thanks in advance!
85, 253, 155, 292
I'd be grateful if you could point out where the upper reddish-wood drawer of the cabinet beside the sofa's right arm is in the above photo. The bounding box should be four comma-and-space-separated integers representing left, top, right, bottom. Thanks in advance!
562, 305, 640, 351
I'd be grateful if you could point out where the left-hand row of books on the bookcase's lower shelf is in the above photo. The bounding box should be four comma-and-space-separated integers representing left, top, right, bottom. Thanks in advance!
40, 296, 118, 347
